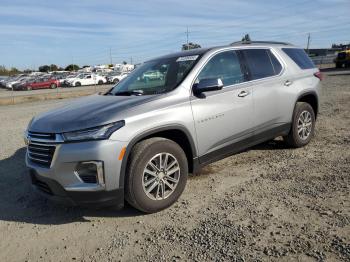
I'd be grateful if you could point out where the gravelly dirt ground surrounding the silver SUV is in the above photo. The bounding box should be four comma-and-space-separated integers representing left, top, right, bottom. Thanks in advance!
0, 72, 350, 261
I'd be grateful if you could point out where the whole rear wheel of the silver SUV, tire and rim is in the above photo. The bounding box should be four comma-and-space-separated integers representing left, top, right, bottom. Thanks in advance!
284, 102, 315, 148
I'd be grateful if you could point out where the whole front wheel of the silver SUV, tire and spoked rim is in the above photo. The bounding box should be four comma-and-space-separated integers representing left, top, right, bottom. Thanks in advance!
125, 137, 188, 213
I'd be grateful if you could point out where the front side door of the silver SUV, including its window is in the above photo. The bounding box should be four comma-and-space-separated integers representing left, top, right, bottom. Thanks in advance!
191, 50, 253, 160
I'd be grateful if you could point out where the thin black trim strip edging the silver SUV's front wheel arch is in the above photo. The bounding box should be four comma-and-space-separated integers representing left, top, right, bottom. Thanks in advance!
119, 124, 198, 188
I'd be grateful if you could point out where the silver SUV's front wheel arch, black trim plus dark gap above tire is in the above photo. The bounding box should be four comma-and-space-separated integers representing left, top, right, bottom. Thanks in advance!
119, 125, 198, 187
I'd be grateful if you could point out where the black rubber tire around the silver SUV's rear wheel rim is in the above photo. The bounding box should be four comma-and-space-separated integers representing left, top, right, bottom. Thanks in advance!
283, 102, 315, 148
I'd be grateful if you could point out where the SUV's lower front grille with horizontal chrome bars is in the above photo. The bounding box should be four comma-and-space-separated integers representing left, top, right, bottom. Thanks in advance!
28, 143, 56, 167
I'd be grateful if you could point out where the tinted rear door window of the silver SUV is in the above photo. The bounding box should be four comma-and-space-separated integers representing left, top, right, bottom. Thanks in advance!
241, 49, 282, 80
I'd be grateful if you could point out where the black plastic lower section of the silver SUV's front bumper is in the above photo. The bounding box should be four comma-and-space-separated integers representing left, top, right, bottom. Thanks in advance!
29, 169, 124, 209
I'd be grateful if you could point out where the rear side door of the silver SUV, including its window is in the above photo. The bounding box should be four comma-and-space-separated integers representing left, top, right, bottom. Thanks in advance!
240, 48, 288, 134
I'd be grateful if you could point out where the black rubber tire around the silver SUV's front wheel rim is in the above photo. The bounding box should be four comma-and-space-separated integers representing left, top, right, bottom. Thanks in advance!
125, 137, 188, 213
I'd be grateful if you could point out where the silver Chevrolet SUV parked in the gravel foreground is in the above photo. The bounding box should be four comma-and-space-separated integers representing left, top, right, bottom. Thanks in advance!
25, 42, 322, 212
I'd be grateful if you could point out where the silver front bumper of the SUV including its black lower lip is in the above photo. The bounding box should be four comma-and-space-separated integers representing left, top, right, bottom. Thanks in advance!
26, 140, 125, 206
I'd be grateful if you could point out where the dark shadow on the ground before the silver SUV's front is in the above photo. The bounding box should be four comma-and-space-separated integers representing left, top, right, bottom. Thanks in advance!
0, 147, 144, 225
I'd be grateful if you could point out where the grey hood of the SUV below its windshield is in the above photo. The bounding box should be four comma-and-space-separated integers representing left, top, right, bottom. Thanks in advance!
29, 95, 156, 133
